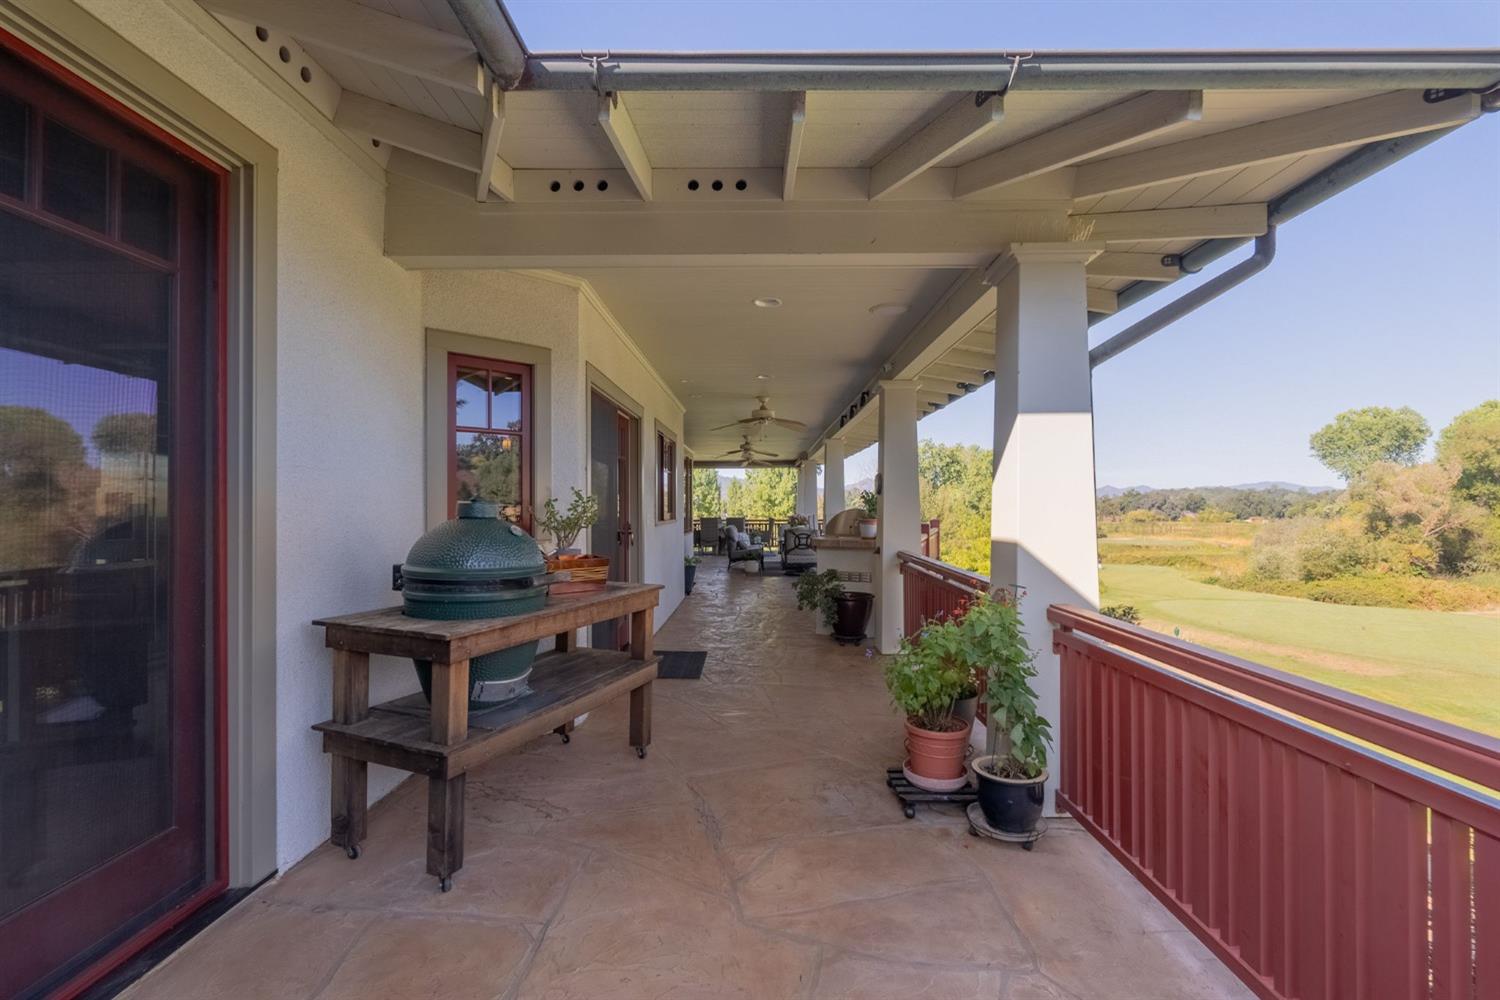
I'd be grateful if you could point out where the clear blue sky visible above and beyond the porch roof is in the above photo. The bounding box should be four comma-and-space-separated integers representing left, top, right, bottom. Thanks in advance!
509, 0, 1500, 486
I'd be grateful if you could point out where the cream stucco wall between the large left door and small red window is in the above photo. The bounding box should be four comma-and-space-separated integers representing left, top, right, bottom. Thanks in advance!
81, 0, 423, 868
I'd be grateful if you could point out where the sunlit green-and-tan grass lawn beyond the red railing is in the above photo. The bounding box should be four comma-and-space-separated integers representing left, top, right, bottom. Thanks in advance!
1100, 564, 1500, 736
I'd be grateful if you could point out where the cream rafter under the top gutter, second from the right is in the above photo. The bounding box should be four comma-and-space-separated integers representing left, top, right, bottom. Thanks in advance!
953, 90, 1203, 198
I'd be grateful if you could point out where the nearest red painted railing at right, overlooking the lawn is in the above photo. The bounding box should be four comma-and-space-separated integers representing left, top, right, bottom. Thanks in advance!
1049, 606, 1500, 1000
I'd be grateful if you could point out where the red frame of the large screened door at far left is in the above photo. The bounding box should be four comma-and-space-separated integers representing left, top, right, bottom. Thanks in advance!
0, 28, 230, 1000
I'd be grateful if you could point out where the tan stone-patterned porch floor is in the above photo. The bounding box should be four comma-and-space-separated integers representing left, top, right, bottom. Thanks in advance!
129, 559, 1250, 1000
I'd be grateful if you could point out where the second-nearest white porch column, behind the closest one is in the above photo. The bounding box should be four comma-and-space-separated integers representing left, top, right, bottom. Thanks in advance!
876, 381, 923, 652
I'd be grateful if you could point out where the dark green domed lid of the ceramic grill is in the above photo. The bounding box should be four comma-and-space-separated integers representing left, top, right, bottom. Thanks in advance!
401, 501, 546, 582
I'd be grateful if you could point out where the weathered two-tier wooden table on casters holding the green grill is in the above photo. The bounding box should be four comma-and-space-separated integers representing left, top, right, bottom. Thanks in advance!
314, 583, 662, 892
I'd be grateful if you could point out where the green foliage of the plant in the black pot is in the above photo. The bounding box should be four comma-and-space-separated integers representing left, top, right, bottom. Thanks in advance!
959, 594, 1052, 780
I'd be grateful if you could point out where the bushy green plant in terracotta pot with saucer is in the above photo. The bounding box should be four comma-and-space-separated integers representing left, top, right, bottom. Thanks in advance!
885, 619, 974, 792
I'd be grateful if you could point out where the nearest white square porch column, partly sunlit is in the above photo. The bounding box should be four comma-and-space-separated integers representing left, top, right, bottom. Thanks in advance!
990, 243, 1101, 813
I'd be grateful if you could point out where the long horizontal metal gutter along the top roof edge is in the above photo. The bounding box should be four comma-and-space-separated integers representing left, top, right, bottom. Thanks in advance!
519, 50, 1500, 91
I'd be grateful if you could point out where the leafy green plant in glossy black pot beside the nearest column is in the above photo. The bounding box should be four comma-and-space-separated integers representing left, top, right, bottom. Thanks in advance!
960, 595, 1052, 834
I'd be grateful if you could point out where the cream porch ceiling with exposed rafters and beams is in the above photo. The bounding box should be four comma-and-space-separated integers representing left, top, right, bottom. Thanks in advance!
200, 0, 1500, 457
